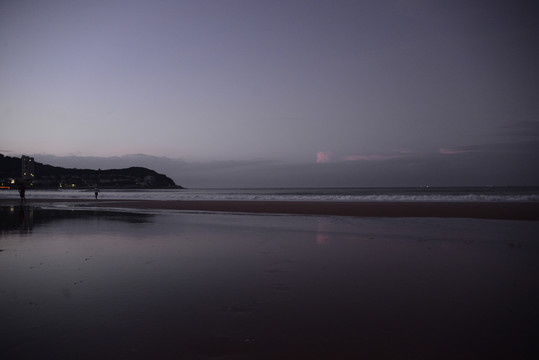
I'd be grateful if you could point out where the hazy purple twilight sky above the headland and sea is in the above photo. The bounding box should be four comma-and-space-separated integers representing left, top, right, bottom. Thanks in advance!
0, 0, 539, 187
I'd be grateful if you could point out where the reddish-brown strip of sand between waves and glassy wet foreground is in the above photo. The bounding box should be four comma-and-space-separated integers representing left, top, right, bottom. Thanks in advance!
0, 199, 539, 220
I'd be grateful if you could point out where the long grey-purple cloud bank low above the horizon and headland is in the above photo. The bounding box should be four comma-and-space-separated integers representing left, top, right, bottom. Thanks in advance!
24, 140, 539, 188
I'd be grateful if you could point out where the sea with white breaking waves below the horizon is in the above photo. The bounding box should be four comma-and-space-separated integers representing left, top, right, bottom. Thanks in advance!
0, 187, 539, 202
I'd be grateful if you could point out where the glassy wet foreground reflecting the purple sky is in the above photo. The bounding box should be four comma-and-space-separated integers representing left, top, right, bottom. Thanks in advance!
0, 206, 539, 359
